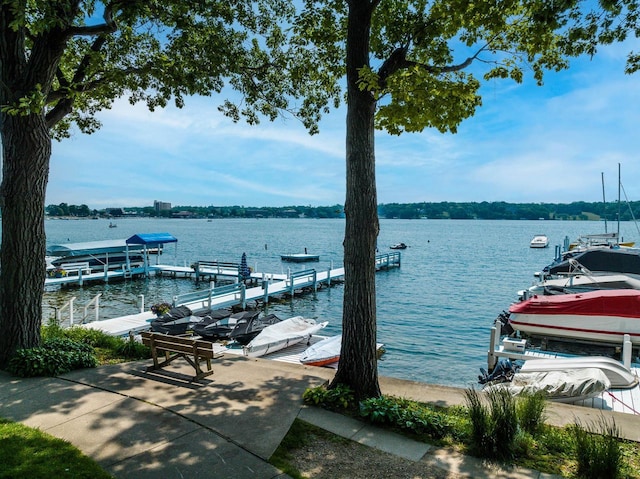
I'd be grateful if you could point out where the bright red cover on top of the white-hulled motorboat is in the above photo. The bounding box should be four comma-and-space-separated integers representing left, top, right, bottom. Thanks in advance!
509, 289, 640, 318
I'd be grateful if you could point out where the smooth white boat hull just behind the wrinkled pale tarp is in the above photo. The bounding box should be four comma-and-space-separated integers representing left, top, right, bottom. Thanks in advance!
520, 356, 638, 389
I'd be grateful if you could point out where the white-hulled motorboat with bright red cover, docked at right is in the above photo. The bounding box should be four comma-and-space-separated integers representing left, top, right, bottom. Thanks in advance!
509, 289, 640, 344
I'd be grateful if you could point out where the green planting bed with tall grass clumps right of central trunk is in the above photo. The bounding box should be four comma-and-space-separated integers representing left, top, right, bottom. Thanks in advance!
300, 386, 640, 479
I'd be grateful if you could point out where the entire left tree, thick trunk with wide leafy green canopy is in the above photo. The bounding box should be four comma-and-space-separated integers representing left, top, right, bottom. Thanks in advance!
0, 0, 341, 366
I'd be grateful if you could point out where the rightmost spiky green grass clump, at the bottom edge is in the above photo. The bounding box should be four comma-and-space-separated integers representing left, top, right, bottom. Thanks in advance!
571, 418, 623, 479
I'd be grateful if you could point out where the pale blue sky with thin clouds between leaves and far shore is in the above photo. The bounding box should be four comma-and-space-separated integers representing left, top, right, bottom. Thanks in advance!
46, 38, 640, 209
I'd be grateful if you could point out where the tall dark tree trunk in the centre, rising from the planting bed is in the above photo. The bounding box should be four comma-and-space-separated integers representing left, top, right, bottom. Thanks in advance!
332, 0, 380, 400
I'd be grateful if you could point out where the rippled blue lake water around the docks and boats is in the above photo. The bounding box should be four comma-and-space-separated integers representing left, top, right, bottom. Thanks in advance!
43, 218, 638, 387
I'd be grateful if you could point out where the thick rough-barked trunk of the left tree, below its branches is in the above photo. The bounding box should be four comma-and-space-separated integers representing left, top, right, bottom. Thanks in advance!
0, 114, 51, 367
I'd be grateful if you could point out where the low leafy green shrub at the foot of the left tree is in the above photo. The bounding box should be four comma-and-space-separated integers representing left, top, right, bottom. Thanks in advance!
7, 337, 98, 377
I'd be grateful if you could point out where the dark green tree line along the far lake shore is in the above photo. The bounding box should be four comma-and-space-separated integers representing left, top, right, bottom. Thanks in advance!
46, 201, 640, 221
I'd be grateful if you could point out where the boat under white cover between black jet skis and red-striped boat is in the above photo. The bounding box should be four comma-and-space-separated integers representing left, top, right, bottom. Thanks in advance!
242, 316, 329, 358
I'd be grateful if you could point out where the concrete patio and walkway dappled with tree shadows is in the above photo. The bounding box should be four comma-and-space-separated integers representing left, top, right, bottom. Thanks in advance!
0, 357, 640, 479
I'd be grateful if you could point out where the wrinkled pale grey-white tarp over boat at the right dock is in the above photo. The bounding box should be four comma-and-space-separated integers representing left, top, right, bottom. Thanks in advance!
484, 368, 611, 402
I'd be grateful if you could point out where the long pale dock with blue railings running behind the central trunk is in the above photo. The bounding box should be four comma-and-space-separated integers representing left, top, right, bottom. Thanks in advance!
83, 253, 400, 336
